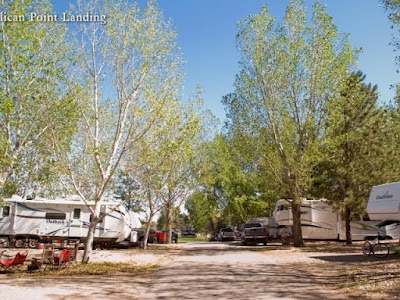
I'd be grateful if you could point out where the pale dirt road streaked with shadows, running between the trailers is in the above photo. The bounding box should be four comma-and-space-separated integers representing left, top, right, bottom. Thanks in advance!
0, 243, 346, 300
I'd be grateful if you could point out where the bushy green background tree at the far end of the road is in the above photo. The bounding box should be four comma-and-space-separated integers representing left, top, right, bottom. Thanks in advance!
185, 134, 275, 234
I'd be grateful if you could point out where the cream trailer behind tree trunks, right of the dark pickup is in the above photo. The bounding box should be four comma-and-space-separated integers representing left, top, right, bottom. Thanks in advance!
274, 199, 385, 241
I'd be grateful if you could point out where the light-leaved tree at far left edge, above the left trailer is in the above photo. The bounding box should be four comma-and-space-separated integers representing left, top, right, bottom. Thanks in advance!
0, 0, 76, 195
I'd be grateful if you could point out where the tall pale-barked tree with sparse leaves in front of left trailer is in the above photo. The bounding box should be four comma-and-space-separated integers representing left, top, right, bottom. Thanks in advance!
54, 0, 182, 263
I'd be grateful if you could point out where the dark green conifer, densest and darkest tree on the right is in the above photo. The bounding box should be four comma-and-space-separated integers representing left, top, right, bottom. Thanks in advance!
314, 71, 388, 244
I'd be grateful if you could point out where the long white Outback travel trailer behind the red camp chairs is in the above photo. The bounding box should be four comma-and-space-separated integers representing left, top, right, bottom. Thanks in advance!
0, 195, 140, 248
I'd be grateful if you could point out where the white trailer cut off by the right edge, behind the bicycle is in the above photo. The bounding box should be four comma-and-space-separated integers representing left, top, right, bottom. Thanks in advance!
367, 182, 400, 239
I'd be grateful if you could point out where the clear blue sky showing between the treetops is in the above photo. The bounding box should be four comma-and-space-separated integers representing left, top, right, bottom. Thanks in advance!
54, 0, 400, 121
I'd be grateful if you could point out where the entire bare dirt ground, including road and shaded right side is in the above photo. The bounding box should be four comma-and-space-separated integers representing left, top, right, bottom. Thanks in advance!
0, 241, 400, 300
